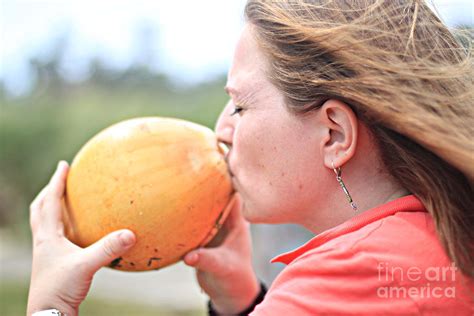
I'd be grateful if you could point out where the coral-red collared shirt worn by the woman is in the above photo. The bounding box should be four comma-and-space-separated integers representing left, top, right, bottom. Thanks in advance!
251, 195, 474, 316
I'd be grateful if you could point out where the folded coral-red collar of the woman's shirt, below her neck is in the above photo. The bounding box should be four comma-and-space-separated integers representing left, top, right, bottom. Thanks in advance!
271, 195, 426, 264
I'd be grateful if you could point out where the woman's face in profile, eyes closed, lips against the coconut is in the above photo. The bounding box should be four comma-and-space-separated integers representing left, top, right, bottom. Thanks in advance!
216, 25, 327, 223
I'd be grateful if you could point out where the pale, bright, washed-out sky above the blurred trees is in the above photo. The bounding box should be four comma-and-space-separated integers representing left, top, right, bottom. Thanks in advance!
0, 0, 474, 95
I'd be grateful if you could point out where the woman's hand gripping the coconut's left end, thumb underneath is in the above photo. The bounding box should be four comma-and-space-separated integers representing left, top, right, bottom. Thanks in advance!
27, 161, 136, 316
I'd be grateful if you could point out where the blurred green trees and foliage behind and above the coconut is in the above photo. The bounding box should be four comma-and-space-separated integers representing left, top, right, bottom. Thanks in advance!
0, 48, 227, 240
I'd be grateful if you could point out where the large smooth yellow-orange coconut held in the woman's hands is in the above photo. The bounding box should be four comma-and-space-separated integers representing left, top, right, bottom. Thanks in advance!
64, 117, 233, 271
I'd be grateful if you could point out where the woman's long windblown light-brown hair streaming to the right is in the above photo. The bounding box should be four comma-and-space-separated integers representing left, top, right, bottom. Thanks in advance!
245, 0, 474, 276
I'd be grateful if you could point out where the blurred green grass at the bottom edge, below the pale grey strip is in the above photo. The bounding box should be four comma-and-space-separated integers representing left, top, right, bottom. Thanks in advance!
0, 283, 205, 316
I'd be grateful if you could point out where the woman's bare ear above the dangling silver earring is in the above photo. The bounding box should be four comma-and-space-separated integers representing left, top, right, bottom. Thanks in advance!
318, 99, 358, 169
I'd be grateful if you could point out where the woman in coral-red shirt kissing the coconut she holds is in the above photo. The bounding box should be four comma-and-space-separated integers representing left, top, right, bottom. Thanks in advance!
28, 0, 474, 315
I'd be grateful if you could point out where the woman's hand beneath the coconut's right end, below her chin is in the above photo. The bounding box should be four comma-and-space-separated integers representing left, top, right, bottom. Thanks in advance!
184, 194, 260, 314
